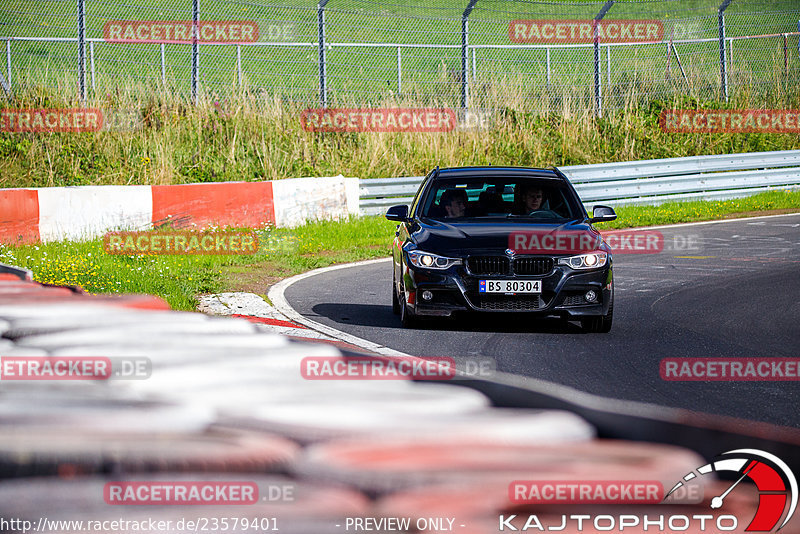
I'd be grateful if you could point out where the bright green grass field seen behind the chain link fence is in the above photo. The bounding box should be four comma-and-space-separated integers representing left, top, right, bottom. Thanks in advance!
0, 0, 800, 107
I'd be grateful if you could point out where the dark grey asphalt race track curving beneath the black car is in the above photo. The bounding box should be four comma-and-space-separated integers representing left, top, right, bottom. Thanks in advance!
285, 214, 800, 427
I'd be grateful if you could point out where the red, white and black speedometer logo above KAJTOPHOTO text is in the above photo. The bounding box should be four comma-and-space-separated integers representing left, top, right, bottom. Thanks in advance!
667, 449, 797, 532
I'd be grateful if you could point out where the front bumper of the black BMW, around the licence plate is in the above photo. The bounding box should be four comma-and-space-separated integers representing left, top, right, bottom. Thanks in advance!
404, 256, 613, 318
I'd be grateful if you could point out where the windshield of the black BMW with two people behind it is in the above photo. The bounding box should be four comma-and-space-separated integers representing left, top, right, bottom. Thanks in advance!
421, 177, 582, 220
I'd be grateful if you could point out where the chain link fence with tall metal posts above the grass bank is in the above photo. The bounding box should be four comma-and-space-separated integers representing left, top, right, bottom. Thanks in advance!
0, 0, 800, 114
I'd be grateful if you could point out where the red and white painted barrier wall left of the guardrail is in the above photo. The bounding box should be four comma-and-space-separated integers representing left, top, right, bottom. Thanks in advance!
0, 175, 358, 243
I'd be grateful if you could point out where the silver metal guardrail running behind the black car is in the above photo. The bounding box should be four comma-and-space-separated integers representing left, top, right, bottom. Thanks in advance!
359, 150, 800, 215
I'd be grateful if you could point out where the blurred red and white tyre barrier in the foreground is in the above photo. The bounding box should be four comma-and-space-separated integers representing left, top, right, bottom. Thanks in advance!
0, 265, 800, 534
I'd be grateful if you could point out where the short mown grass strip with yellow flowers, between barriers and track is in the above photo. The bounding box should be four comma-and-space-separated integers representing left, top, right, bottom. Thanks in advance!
0, 191, 800, 310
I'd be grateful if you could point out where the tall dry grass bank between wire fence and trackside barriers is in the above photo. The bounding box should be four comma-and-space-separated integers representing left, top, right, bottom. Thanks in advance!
0, 84, 800, 188
